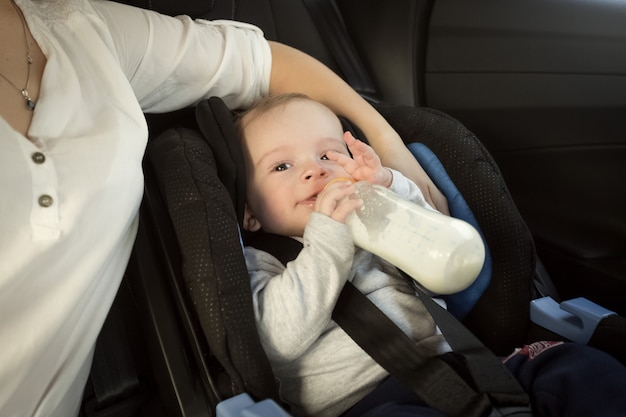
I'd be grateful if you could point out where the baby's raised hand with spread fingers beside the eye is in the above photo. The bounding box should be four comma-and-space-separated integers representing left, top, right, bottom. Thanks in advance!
326, 132, 393, 187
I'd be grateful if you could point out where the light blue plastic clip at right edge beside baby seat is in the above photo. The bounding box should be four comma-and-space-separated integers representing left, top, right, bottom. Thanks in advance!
530, 297, 616, 344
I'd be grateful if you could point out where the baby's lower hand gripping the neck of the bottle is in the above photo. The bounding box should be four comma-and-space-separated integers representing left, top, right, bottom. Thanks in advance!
315, 180, 363, 223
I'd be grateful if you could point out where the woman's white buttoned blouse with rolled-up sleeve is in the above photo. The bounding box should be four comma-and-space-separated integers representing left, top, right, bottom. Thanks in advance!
0, 0, 271, 417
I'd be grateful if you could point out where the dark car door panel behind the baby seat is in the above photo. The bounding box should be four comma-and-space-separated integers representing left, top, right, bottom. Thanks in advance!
338, 0, 626, 313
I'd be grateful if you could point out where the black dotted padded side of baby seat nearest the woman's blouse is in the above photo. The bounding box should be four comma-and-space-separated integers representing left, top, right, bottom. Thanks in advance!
147, 129, 278, 399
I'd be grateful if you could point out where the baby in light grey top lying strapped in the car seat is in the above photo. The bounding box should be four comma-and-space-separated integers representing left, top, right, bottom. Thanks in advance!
234, 95, 448, 416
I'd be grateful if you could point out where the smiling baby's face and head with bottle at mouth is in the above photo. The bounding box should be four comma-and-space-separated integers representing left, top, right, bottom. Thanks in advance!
243, 100, 350, 236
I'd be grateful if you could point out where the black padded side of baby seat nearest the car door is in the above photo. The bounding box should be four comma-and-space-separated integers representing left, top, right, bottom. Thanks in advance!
377, 105, 536, 355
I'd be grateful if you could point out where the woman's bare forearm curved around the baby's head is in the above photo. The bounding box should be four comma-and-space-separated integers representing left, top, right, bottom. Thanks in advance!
270, 42, 449, 214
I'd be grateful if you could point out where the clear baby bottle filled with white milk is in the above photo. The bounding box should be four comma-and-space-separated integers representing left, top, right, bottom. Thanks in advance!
346, 181, 485, 294
